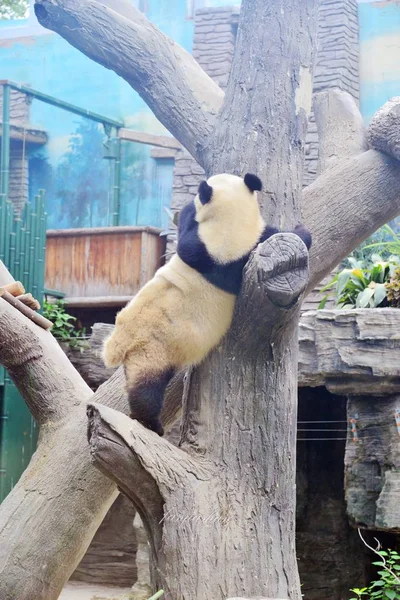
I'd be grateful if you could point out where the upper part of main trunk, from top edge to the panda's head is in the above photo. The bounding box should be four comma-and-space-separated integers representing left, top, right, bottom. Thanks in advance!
208, 0, 317, 229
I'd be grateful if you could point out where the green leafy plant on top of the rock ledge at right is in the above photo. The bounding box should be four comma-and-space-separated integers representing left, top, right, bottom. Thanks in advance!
318, 254, 400, 309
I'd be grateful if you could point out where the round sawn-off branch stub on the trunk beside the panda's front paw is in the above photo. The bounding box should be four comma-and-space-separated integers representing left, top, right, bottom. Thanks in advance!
232, 233, 308, 356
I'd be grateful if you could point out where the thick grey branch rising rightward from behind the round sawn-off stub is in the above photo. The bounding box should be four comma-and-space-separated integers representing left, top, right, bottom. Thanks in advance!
303, 150, 400, 291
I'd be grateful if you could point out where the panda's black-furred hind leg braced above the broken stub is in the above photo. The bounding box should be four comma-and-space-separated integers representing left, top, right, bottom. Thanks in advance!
128, 368, 174, 435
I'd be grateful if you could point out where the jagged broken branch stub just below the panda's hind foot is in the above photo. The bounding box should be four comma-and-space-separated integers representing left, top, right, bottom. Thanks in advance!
87, 404, 211, 496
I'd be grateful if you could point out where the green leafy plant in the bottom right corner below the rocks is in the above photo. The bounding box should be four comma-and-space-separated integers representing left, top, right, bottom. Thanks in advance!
350, 530, 400, 600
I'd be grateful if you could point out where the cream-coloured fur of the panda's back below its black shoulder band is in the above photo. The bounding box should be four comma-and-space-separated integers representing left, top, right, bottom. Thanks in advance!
117, 255, 235, 367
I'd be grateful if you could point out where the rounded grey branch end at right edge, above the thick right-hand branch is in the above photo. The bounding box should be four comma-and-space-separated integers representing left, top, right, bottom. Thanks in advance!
367, 96, 400, 160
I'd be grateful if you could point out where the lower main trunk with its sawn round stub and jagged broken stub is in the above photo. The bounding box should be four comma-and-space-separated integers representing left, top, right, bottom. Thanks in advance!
88, 234, 308, 600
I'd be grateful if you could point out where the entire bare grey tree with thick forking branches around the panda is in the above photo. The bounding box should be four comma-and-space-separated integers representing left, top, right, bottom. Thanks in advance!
0, 0, 400, 600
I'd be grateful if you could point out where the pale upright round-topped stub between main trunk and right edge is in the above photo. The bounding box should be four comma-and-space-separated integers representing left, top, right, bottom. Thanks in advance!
314, 89, 368, 173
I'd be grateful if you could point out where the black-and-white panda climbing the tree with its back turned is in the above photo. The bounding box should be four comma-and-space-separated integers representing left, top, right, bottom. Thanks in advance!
103, 173, 311, 435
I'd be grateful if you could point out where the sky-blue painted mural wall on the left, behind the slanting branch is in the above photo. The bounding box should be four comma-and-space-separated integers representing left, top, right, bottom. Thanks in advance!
0, 0, 198, 228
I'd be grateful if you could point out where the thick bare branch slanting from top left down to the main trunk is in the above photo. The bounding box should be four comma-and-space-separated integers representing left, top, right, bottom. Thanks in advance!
35, 0, 223, 164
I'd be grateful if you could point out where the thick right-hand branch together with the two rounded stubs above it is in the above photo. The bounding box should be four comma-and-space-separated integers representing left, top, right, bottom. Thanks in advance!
302, 96, 400, 291
